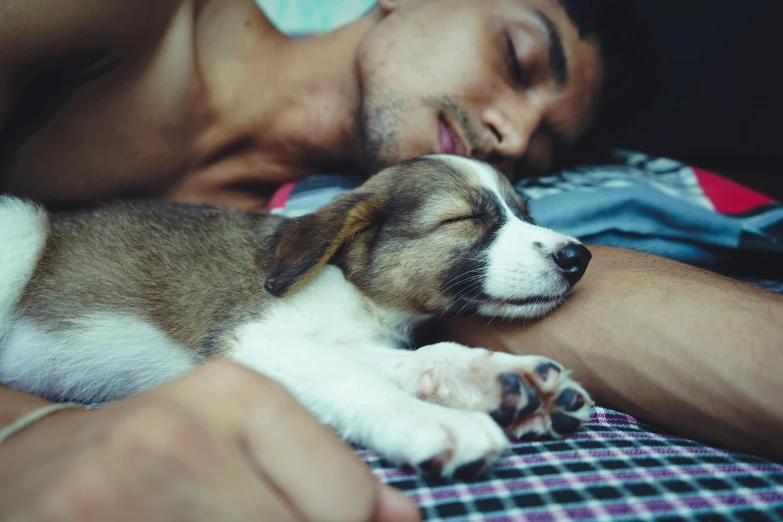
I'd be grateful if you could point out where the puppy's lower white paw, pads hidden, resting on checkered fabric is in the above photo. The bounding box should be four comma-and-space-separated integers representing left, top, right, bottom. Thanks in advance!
377, 403, 509, 479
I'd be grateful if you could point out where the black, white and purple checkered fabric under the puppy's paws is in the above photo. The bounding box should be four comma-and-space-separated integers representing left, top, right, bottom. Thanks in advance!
359, 407, 783, 522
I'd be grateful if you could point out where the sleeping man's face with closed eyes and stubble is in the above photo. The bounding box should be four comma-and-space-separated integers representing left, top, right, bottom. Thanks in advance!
357, 0, 603, 176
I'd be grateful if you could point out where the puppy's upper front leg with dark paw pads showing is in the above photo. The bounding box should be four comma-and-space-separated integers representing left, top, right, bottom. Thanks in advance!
344, 343, 593, 438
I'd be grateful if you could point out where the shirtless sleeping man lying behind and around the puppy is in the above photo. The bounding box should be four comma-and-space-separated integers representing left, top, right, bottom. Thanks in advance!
0, 0, 783, 520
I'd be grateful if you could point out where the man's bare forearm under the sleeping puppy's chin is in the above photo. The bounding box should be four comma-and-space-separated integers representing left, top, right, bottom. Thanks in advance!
446, 247, 783, 460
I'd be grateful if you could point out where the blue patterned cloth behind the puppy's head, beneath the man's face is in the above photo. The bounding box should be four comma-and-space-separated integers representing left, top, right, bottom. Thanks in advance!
272, 151, 783, 272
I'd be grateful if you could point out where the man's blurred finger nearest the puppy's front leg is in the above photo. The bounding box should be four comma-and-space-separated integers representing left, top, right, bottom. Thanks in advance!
151, 362, 404, 522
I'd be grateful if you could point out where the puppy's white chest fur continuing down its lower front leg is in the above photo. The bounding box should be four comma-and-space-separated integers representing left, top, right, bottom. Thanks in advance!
231, 266, 508, 473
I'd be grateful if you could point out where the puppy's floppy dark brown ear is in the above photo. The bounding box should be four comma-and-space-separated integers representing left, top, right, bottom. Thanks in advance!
264, 192, 382, 297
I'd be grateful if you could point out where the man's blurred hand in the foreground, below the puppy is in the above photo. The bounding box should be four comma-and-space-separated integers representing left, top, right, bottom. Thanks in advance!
0, 362, 419, 522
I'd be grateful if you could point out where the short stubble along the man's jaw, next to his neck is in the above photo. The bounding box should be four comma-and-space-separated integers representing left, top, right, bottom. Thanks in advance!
355, 82, 408, 176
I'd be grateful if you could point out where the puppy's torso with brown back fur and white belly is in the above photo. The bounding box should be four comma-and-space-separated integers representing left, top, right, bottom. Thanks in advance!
0, 203, 281, 402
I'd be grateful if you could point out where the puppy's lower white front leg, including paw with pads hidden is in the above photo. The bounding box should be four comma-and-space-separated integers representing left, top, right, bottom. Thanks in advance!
229, 327, 508, 476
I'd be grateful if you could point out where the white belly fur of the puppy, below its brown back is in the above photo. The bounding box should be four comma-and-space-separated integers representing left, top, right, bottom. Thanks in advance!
0, 312, 196, 403
